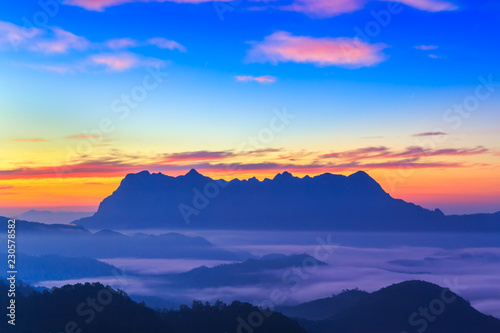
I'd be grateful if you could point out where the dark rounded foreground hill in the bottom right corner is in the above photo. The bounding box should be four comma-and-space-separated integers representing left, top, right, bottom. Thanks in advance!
300, 281, 500, 333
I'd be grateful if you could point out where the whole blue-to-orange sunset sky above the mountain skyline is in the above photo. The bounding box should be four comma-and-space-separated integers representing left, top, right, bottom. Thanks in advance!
0, 0, 500, 215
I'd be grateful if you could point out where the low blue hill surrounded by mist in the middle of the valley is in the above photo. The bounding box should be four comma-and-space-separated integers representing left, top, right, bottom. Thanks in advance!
164, 254, 326, 288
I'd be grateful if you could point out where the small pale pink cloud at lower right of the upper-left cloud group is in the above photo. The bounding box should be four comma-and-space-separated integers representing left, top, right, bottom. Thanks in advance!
89, 52, 166, 72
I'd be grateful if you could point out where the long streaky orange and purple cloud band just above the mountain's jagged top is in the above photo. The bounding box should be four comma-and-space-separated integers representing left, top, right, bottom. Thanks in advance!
0, 146, 484, 180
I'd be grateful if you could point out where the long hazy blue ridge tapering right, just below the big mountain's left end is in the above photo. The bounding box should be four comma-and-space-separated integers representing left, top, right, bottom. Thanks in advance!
0, 217, 253, 261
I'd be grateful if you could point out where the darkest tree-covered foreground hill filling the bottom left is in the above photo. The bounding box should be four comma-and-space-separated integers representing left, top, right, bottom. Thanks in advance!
0, 283, 306, 333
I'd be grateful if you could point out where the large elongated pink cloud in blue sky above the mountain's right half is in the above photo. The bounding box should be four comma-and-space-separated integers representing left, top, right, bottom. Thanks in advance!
246, 31, 387, 68
